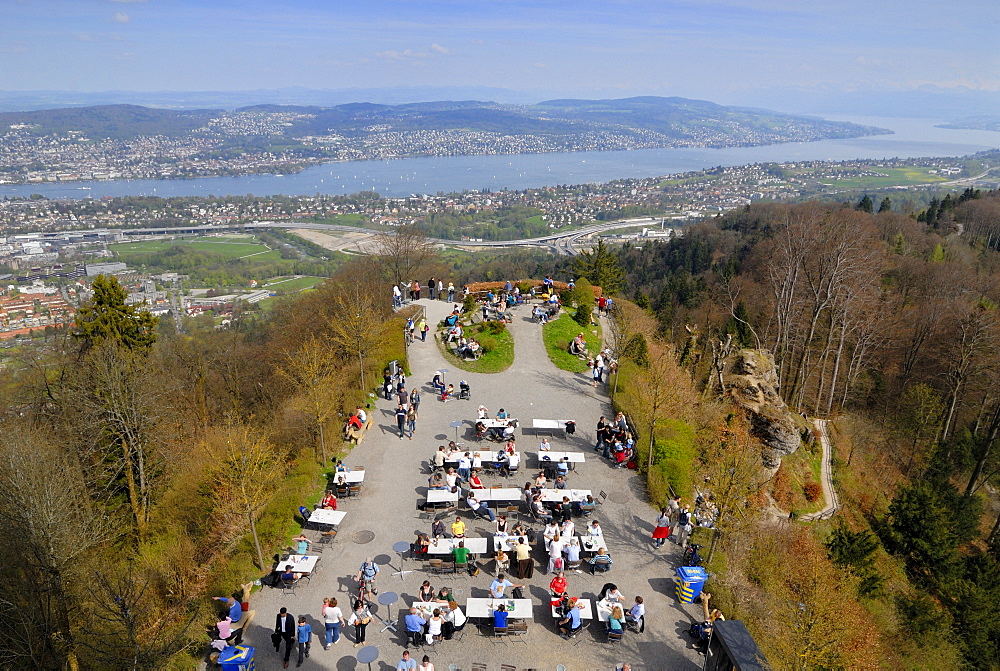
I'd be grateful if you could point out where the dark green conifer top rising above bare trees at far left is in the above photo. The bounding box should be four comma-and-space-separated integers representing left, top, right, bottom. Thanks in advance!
73, 275, 159, 350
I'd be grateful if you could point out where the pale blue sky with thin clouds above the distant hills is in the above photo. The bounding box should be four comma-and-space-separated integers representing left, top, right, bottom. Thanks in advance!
0, 0, 1000, 104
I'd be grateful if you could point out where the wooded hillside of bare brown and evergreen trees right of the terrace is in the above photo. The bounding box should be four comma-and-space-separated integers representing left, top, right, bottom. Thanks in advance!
618, 188, 1000, 669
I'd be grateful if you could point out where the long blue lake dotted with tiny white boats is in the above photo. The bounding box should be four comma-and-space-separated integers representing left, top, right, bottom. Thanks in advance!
0, 117, 1000, 199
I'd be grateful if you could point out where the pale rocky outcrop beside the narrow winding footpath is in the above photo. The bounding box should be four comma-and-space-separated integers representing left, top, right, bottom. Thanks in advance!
720, 349, 802, 469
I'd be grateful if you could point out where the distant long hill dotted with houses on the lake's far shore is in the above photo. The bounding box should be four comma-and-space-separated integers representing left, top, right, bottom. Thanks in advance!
0, 97, 888, 148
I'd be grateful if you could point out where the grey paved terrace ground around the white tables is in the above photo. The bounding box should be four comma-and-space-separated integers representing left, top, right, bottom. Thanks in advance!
246, 299, 702, 671
